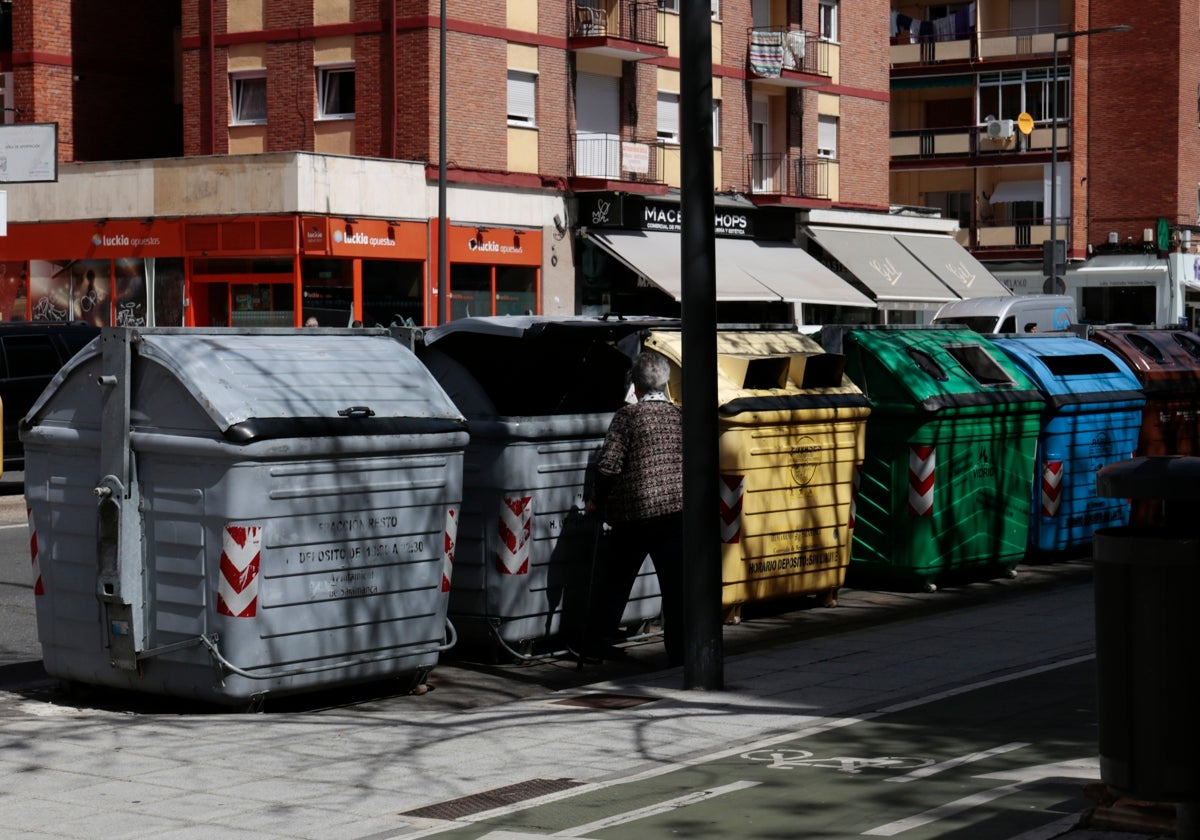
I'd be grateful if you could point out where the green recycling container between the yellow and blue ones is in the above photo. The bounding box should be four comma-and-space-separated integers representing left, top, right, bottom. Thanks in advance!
841, 326, 1043, 592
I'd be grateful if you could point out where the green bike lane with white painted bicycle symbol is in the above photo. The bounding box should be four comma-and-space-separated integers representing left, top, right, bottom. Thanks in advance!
416, 659, 1099, 840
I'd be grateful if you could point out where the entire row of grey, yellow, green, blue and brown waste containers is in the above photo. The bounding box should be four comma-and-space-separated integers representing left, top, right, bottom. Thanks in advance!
22, 317, 1200, 703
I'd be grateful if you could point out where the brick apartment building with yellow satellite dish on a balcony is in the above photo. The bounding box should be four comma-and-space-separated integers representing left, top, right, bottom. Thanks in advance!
890, 0, 1200, 324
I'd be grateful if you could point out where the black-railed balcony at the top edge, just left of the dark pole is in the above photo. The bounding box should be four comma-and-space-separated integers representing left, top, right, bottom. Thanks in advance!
566, 0, 667, 61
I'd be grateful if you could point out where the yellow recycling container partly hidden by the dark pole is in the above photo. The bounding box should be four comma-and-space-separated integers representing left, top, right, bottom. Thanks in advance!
646, 328, 870, 619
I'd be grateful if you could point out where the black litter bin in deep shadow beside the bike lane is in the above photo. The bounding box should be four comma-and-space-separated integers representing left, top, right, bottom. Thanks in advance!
1093, 456, 1200, 806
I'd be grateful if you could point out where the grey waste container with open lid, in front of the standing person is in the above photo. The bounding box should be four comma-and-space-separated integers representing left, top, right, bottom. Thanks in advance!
418, 316, 679, 659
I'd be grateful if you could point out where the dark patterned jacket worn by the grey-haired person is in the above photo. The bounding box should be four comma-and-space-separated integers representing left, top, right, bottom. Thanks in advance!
596, 395, 683, 522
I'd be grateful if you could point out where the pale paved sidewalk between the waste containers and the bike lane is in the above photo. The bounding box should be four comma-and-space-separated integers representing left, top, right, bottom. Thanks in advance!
0, 583, 1169, 840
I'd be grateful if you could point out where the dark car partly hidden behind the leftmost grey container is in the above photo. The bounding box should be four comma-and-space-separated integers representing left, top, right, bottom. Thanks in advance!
0, 322, 100, 472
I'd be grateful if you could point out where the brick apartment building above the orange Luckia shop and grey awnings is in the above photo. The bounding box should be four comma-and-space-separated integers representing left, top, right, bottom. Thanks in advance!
0, 0, 1003, 326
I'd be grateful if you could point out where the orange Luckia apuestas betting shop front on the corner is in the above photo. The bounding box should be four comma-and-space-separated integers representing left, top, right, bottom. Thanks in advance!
0, 215, 441, 326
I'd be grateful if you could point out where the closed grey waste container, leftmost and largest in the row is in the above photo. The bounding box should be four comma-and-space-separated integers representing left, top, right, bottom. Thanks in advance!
22, 329, 467, 704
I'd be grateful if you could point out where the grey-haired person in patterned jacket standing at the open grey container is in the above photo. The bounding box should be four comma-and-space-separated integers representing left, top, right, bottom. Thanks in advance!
587, 353, 683, 665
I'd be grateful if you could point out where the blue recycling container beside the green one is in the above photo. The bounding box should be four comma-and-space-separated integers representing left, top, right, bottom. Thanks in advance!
991, 335, 1146, 559
